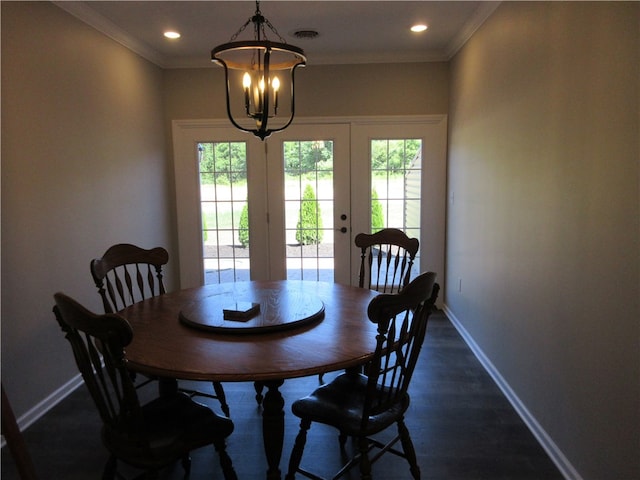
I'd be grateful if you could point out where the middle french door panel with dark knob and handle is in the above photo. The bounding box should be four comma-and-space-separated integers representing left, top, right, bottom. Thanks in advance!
266, 124, 351, 284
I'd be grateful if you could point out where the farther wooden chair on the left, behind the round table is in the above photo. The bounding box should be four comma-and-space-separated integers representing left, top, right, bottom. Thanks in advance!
90, 243, 229, 417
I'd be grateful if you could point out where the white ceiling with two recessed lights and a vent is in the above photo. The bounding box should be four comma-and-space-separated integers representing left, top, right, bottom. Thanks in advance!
54, 0, 499, 68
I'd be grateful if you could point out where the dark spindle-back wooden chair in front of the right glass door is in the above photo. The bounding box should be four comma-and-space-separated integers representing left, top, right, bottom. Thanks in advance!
355, 228, 420, 293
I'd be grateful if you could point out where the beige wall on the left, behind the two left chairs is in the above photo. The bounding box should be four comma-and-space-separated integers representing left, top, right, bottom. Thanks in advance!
1, 2, 173, 417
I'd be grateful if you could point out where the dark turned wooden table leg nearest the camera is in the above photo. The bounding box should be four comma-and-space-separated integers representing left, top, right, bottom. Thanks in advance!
262, 380, 284, 480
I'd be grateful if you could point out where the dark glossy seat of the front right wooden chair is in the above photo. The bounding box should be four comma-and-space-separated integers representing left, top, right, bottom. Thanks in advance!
291, 372, 410, 436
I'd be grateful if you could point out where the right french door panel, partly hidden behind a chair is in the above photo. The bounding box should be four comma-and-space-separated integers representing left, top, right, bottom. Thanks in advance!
351, 119, 447, 285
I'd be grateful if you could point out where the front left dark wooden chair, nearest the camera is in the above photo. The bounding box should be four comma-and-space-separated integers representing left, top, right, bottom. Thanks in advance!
53, 293, 237, 479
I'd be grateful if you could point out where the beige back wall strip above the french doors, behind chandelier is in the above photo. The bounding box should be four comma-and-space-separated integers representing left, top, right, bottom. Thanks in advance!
164, 62, 449, 123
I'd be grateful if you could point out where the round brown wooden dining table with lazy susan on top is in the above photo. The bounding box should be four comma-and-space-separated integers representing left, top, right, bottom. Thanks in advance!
119, 280, 378, 479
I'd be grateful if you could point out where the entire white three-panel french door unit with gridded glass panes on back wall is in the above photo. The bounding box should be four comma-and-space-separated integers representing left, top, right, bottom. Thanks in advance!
173, 116, 446, 287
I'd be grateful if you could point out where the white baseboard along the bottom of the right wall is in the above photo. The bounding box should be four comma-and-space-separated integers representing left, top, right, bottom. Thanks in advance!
444, 305, 582, 480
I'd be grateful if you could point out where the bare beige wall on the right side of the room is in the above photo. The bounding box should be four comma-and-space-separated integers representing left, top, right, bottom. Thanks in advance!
446, 2, 640, 480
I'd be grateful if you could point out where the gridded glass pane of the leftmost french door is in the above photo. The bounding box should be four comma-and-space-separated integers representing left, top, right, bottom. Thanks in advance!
198, 142, 249, 285
